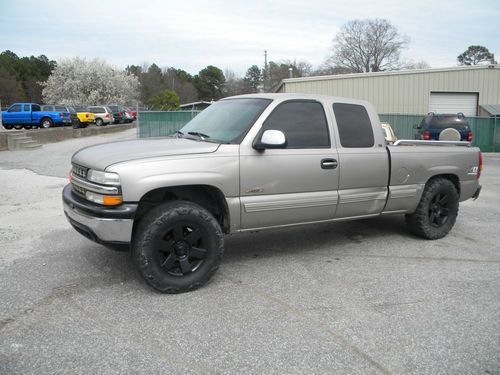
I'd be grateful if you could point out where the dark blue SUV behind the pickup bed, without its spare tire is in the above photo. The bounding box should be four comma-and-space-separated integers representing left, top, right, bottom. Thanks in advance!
415, 112, 472, 142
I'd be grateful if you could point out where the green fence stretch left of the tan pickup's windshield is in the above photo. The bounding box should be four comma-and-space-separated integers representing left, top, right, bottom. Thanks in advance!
138, 111, 200, 138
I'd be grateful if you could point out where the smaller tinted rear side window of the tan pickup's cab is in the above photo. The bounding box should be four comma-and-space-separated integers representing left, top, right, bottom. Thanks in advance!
333, 103, 375, 147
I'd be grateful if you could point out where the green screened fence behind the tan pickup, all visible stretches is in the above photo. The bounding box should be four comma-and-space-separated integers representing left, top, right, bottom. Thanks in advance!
138, 111, 500, 152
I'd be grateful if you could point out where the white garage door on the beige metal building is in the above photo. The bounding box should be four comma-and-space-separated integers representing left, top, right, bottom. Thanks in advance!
429, 92, 477, 116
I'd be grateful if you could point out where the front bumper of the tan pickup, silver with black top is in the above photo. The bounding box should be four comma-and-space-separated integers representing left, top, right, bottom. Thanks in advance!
62, 184, 137, 245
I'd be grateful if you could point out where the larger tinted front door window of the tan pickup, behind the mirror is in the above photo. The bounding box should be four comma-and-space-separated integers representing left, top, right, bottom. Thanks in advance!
263, 101, 330, 148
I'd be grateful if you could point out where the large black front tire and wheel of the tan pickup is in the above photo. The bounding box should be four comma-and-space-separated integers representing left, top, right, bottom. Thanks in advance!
132, 201, 224, 293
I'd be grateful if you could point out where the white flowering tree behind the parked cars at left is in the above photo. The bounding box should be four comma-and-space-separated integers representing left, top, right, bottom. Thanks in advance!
42, 57, 140, 105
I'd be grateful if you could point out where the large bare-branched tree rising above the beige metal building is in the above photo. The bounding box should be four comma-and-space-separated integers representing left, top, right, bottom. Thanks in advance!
328, 18, 409, 73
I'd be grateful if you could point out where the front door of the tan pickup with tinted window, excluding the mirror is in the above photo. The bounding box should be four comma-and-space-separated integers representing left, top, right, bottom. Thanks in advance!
240, 99, 339, 229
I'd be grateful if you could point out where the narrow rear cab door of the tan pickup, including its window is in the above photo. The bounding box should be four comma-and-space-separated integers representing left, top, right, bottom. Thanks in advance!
332, 102, 389, 218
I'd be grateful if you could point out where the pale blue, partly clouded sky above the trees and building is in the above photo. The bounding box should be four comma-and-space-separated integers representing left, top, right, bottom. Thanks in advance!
0, 0, 500, 75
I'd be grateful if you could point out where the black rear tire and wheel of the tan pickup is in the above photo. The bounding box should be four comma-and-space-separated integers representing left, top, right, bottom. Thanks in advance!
405, 177, 459, 240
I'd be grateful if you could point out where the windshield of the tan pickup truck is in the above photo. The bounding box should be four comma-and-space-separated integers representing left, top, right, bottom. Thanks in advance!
180, 98, 271, 144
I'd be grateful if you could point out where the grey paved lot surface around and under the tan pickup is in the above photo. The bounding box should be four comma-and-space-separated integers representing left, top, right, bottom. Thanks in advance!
0, 130, 500, 374
